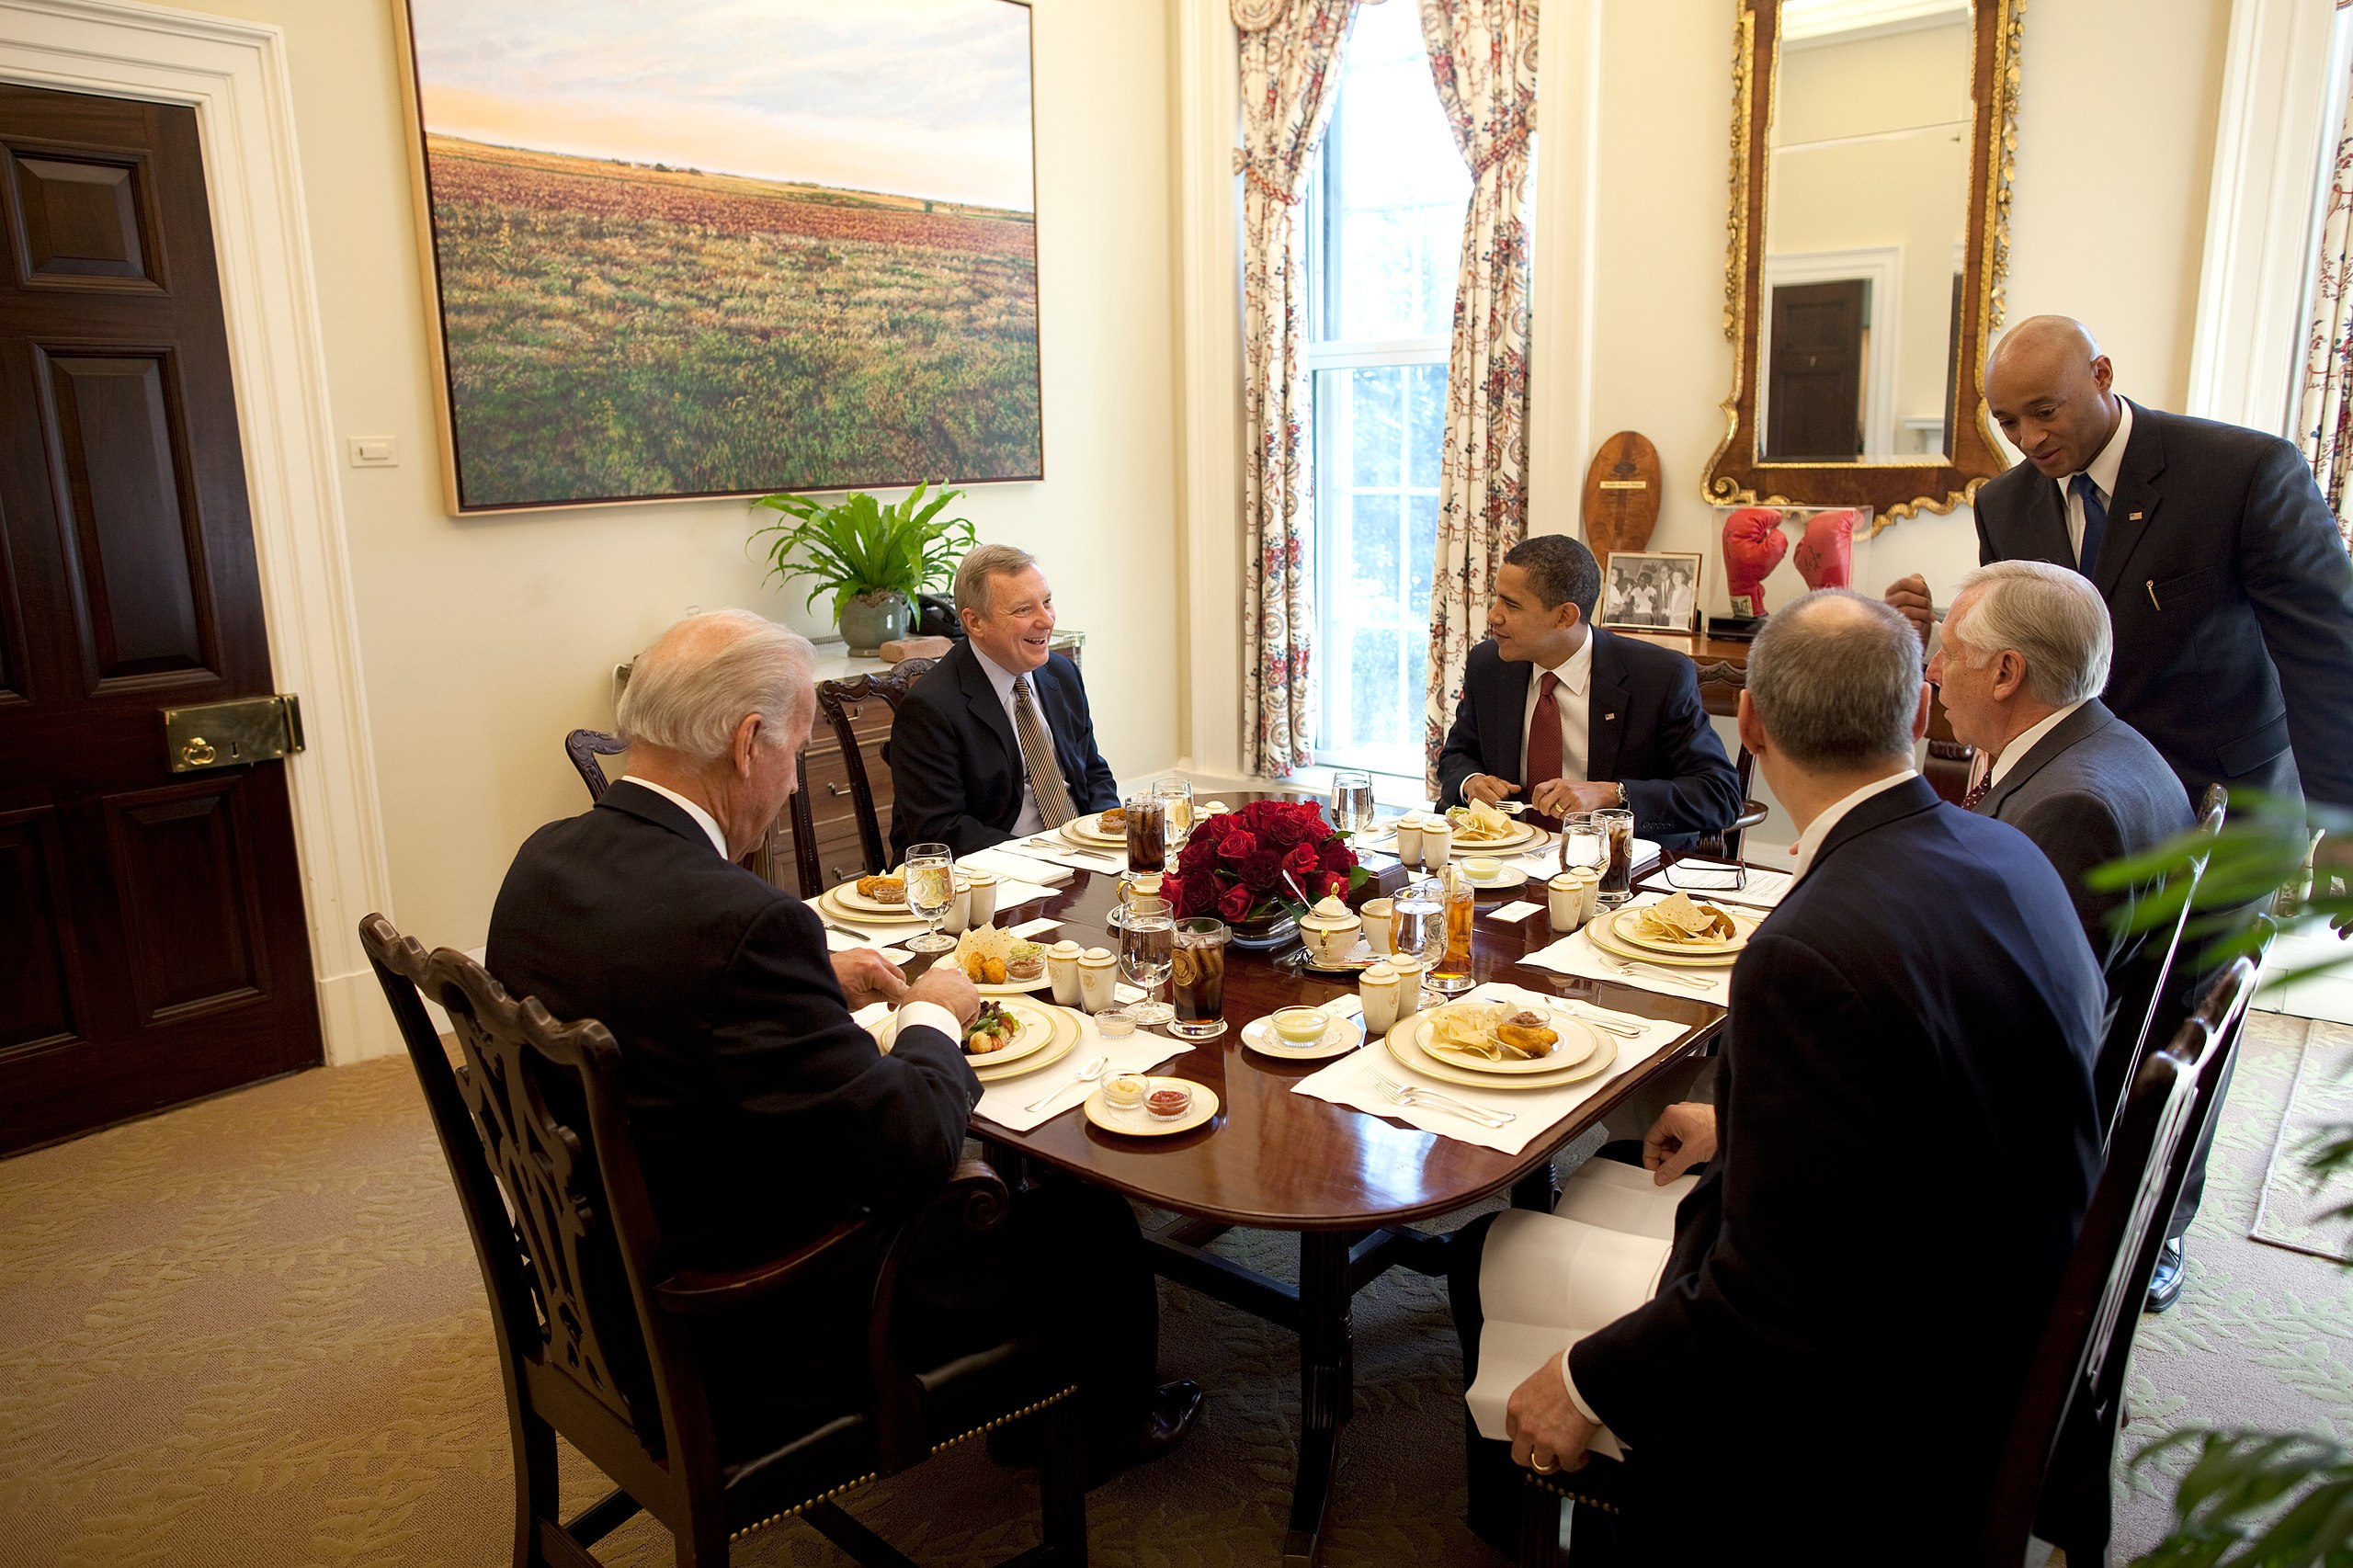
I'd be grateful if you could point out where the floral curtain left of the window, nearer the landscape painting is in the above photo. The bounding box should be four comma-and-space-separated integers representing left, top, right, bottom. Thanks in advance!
1233, 0, 1353, 777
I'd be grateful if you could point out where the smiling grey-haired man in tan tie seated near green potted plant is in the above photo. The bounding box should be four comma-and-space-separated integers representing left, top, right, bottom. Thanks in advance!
887, 544, 1120, 857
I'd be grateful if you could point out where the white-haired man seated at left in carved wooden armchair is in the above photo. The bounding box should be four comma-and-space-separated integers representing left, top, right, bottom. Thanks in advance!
487, 609, 1200, 1474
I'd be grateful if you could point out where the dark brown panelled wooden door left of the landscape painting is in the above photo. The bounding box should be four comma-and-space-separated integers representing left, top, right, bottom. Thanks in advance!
0, 87, 320, 1152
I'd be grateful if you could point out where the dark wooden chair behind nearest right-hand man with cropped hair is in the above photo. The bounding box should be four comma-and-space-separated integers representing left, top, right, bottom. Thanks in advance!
1984, 932, 2264, 1568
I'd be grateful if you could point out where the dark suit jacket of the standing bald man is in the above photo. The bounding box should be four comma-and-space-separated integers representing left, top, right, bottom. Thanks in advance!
1976, 403, 2353, 805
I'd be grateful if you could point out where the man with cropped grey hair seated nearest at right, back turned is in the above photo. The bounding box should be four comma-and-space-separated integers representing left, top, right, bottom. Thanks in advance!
1452, 588, 2101, 1563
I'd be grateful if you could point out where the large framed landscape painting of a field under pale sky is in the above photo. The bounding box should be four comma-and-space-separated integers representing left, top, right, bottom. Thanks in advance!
393, 0, 1045, 513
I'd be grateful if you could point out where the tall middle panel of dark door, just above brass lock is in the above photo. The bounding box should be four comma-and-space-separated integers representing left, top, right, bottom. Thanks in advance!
33, 347, 211, 683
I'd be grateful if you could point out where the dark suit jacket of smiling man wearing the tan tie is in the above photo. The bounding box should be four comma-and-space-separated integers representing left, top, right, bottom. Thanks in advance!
885, 642, 1120, 859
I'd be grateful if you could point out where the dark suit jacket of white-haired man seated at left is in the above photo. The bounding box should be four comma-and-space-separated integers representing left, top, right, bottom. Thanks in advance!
487, 781, 982, 1267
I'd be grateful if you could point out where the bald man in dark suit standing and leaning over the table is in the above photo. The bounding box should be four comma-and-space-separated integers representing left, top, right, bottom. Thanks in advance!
1887, 315, 2353, 805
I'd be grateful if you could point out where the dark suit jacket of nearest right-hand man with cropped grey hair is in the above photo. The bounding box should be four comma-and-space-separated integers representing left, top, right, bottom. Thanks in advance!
1570, 779, 2101, 1535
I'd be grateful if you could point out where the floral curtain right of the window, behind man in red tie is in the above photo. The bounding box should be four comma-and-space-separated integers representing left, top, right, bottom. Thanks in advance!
1421, 0, 1537, 796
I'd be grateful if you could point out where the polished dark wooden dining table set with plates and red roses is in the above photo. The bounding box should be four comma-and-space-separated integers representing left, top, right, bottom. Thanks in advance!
889, 791, 1724, 1563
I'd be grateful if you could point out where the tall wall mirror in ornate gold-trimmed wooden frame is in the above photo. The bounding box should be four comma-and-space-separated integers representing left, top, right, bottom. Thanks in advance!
1703, 0, 2024, 532
